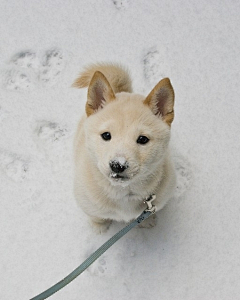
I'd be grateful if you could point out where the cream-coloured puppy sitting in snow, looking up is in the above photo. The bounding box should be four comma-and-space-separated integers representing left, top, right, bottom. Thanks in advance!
73, 64, 175, 232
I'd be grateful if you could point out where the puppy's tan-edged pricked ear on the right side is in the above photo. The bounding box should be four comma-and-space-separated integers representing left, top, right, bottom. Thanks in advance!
143, 78, 174, 126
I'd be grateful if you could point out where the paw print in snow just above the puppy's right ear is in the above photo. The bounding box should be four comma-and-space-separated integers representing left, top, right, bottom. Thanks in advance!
143, 48, 170, 86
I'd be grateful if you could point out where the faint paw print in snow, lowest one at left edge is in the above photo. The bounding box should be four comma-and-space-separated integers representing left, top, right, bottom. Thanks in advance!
0, 150, 31, 182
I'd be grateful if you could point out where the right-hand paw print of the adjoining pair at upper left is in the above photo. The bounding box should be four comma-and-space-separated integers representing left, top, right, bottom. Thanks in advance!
39, 49, 64, 85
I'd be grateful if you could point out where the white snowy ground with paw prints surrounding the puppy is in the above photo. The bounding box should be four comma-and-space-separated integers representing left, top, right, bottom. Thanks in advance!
0, 0, 240, 300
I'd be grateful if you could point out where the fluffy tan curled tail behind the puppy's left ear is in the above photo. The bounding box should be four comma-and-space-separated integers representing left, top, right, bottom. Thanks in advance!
72, 64, 132, 93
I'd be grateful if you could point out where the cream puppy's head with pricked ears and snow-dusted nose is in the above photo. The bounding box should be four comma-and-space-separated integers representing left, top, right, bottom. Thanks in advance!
84, 72, 174, 186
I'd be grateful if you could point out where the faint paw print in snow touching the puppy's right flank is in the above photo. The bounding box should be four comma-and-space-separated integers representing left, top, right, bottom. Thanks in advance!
174, 156, 192, 197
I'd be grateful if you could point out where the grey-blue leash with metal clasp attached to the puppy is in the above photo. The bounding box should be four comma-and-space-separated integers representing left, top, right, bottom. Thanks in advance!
30, 194, 156, 300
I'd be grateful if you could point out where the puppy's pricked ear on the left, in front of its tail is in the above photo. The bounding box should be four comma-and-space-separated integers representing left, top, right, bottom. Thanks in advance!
86, 71, 115, 117
